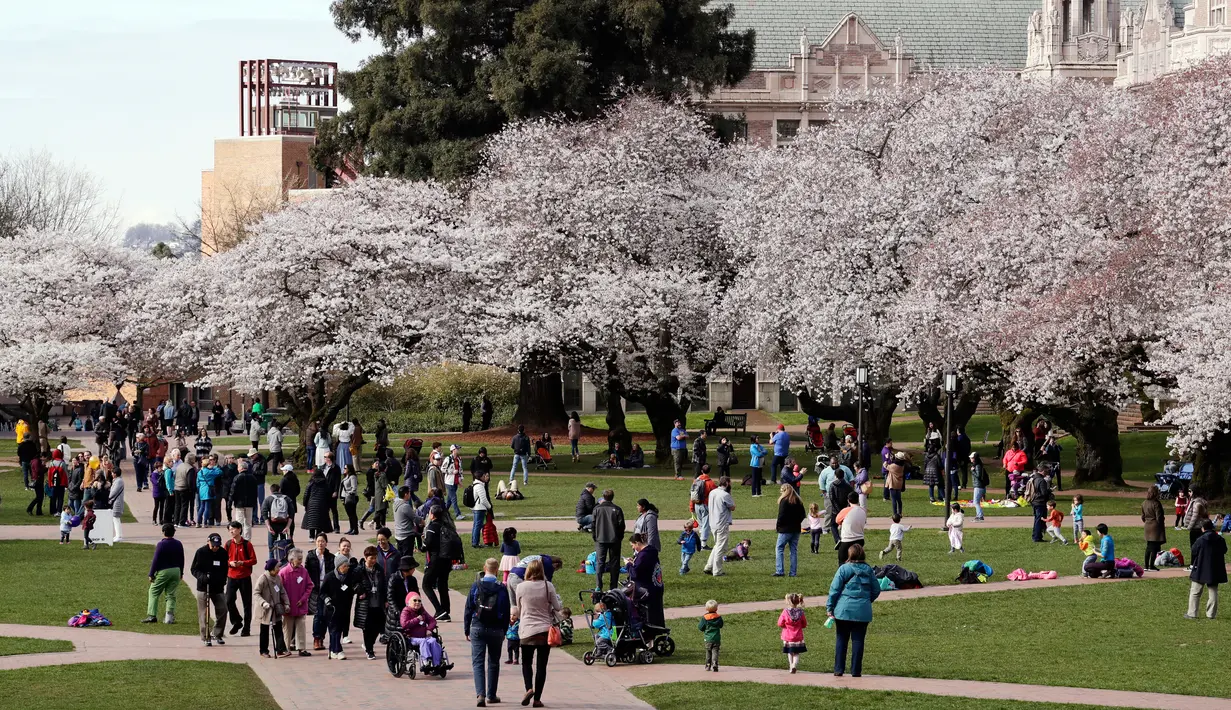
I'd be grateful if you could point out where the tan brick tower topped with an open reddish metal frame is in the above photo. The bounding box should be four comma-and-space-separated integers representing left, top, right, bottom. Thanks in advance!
201, 59, 337, 253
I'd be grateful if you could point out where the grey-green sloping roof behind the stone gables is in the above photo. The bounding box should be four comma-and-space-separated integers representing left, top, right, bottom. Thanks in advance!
713, 0, 1043, 69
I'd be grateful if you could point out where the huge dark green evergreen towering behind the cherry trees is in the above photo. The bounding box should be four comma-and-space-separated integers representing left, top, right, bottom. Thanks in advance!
314, 0, 753, 181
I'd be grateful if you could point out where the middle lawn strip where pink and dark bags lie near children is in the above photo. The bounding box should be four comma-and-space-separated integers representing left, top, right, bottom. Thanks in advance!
449, 521, 1147, 607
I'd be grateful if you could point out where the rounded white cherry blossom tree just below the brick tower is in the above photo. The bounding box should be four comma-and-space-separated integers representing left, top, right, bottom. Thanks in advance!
154, 180, 486, 457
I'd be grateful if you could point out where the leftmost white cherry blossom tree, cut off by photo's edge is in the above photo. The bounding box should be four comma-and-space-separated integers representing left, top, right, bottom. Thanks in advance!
0, 230, 150, 426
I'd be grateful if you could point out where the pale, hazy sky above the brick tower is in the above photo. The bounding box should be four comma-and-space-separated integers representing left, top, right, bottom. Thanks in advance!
0, 0, 379, 234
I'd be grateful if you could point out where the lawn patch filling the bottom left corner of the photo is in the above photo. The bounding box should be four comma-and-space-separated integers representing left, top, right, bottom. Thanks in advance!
0, 660, 279, 710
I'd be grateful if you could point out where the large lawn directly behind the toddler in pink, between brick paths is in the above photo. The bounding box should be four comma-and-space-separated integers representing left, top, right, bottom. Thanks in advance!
610, 580, 1231, 698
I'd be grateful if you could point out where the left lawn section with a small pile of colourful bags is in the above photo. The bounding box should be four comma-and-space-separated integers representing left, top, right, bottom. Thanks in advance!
0, 535, 197, 635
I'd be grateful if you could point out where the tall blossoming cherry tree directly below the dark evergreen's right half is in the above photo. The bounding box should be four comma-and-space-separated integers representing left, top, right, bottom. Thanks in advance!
473, 97, 737, 458
